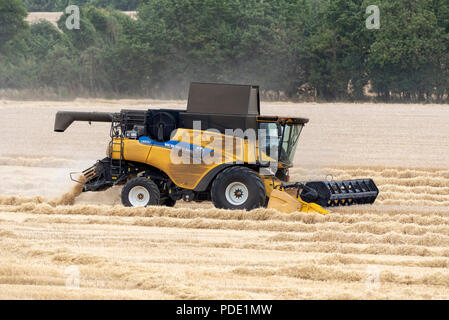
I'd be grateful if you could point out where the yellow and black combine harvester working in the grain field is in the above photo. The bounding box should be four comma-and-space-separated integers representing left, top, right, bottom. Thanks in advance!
55, 83, 379, 214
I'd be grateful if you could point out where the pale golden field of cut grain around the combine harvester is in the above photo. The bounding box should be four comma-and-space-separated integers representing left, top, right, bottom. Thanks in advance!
0, 99, 449, 299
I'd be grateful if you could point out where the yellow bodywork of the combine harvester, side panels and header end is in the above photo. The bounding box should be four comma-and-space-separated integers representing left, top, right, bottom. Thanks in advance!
111, 129, 329, 214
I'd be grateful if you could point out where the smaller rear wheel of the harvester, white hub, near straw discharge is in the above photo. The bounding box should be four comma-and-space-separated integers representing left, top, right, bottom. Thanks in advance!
122, 178, 161, 207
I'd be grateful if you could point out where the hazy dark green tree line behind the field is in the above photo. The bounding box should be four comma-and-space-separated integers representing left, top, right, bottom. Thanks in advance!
0, 0, 449, 103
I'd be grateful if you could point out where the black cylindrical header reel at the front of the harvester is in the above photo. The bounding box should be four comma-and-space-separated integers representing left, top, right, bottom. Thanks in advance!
305, 179, 379, 207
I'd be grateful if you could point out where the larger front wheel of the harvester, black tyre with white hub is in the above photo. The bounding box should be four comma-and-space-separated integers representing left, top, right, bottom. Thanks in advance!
211, 167, 266, 210
